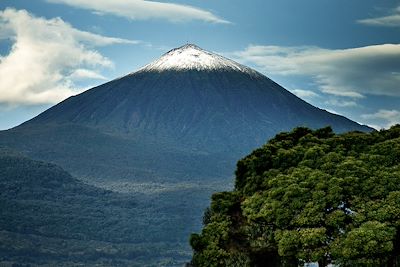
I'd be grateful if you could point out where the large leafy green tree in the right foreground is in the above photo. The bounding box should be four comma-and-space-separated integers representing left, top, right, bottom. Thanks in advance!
190, 125, 400, 266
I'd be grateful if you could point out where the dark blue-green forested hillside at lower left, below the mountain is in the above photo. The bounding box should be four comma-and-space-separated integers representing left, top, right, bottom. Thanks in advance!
0, 149, 197, 266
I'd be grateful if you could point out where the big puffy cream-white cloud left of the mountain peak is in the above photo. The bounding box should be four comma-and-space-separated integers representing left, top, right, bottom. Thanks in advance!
0, 8, 137, 104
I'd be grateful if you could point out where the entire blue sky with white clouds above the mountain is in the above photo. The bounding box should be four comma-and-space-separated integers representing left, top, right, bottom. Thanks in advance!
0, 0, 400, 130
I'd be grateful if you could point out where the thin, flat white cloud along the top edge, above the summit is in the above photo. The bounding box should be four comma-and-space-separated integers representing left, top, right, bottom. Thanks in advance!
47, 0, 230, 23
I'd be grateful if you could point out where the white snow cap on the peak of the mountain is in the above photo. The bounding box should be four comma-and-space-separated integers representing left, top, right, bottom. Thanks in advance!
139, 44, 260, 75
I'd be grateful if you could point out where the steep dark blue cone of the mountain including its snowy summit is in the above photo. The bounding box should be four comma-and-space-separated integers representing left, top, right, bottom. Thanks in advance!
20, 45, 368, 154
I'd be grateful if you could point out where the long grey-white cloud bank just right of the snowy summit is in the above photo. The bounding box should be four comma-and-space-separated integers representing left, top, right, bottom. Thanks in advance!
230, 44, 400, 99
